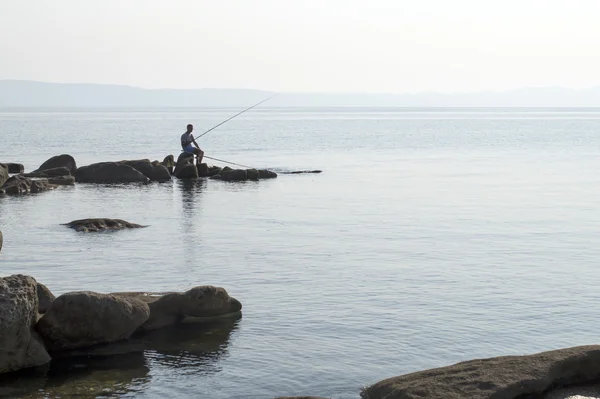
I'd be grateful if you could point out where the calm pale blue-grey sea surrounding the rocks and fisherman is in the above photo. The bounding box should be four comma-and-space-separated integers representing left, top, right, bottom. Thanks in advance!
0, 104, 600, 399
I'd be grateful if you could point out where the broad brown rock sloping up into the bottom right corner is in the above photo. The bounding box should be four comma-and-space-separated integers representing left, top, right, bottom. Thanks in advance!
362, 345, 600, 399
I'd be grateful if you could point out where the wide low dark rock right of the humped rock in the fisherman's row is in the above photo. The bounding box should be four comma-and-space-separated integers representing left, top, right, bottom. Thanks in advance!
75, 162, 150, 184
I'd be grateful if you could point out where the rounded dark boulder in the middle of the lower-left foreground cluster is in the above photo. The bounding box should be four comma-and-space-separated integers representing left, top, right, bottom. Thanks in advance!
36, 291, 150, 352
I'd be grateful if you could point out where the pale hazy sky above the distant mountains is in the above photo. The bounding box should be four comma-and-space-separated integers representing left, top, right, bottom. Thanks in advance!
0, 0, 600, 93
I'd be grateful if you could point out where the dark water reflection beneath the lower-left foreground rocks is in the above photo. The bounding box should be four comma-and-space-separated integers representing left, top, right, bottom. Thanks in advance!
0, 316, 241, 399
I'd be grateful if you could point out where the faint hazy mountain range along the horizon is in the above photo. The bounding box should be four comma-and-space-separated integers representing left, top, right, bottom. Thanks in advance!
0, 80, 600, 107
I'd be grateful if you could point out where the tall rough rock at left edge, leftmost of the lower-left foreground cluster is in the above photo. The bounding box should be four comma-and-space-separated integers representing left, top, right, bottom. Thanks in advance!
0, 275, 50, 373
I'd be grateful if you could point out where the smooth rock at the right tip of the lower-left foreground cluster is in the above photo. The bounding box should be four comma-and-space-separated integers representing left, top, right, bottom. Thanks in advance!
113, 285, 242, 331
